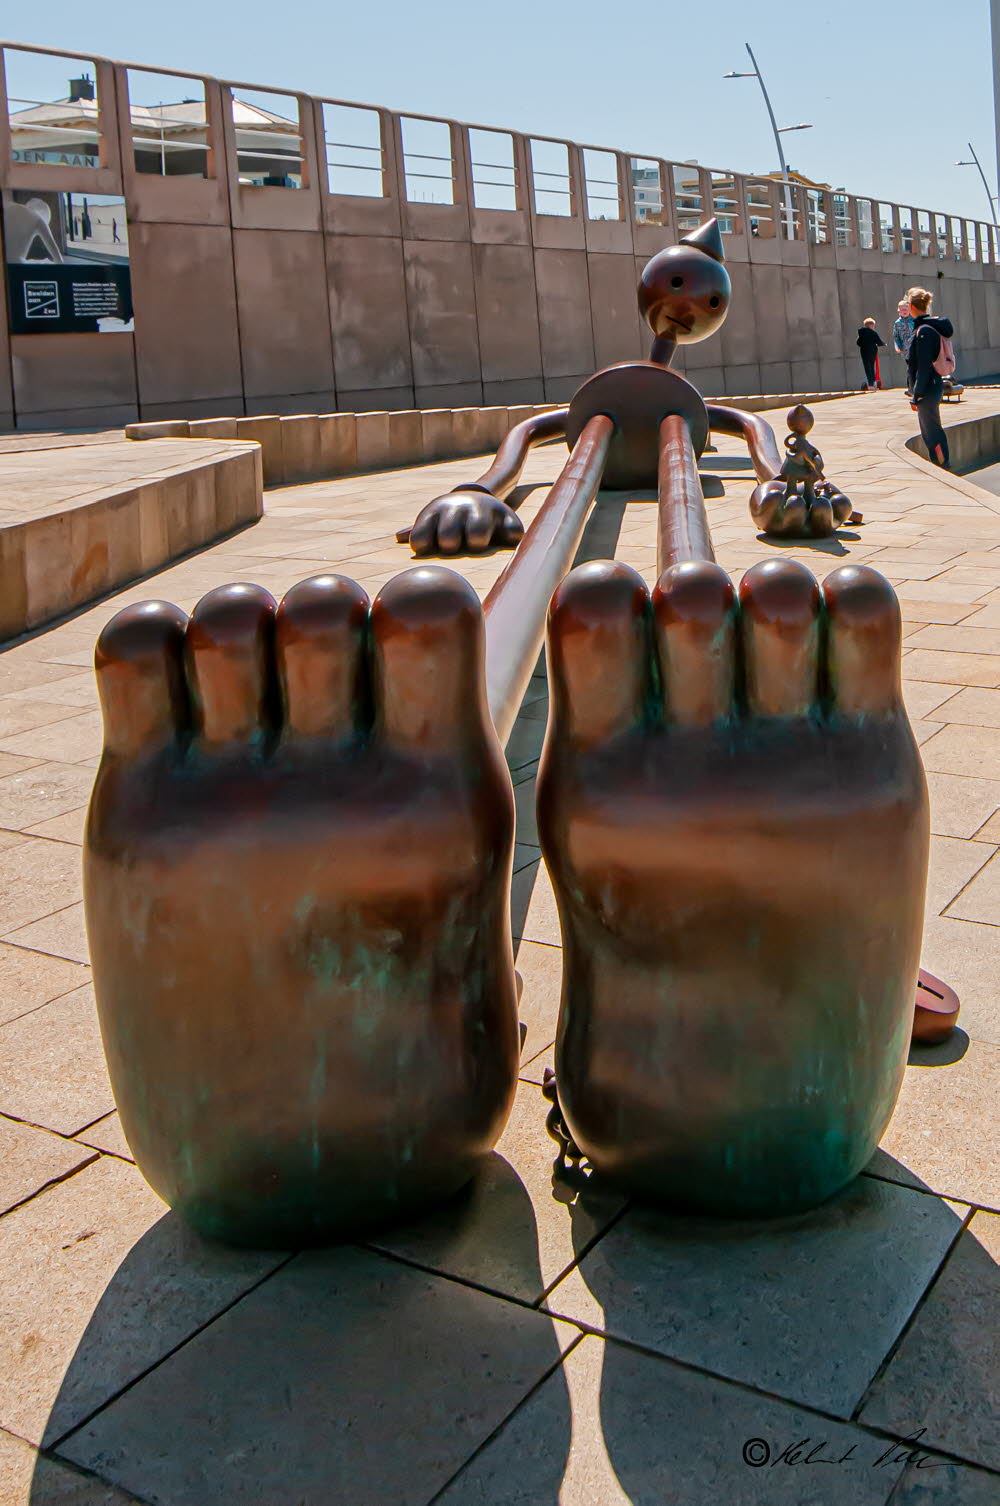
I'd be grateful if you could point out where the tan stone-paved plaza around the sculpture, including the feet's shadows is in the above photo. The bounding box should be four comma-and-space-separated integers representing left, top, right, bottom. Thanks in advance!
0, 392, 1000, 1506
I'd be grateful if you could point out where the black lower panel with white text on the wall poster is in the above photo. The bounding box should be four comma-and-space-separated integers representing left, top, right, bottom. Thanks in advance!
8, 262, 133, 334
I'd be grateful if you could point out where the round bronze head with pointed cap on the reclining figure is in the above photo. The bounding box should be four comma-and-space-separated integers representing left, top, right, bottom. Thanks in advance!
639, 220, 732, 345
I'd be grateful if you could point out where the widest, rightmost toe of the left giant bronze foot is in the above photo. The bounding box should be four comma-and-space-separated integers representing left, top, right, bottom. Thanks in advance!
372, 565, 491, 751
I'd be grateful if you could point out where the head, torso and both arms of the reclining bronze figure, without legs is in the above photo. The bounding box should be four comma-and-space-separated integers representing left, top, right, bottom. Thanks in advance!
396, 218, 860, 557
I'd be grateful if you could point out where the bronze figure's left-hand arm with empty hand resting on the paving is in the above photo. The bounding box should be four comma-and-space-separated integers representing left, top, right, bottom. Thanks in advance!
396, 408, 569, 556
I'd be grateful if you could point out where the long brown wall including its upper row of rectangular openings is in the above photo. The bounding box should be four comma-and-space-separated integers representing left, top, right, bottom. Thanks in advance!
0, 44, 1000, 428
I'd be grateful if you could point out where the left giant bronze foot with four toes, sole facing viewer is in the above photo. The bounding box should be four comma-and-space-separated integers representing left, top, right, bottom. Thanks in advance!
84, 566, 518, 1247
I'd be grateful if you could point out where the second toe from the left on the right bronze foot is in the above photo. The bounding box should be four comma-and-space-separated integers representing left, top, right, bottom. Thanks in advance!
652, 560, 736, 726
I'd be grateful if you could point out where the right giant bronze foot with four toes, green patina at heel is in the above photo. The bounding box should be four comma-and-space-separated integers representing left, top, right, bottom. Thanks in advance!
538, 559, 928, 1215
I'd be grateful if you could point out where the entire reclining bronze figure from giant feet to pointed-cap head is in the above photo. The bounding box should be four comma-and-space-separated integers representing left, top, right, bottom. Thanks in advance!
84, 219, 940, 1245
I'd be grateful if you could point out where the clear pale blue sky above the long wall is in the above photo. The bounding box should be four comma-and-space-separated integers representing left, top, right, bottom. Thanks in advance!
3, 0, 995, 218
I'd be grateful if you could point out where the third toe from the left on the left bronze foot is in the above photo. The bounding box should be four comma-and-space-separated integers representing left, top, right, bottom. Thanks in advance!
276, 575, 369, 738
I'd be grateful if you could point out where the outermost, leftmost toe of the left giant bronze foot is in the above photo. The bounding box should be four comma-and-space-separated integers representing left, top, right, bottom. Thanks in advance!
95, 601, 190, 756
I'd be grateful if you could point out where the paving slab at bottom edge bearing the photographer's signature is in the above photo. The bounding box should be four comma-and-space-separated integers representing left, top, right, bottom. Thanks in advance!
435, 1337, 901, 1506
